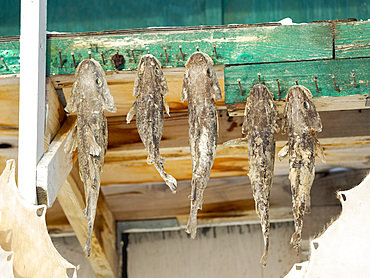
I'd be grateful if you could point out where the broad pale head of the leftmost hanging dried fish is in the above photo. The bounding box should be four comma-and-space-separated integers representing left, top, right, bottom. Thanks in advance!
65, 59, 116, 113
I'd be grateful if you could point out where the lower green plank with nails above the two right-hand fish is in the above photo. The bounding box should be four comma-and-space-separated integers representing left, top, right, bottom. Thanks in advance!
225, 58, 370, 107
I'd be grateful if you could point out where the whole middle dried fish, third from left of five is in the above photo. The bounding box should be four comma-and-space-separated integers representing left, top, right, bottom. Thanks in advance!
181, 52, 222, 238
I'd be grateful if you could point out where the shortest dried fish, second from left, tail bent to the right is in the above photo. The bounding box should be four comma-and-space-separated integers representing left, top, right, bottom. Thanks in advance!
126, 54, 177, 193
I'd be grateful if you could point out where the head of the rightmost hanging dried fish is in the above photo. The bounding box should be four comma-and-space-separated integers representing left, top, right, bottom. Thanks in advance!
284, 85, 322, 132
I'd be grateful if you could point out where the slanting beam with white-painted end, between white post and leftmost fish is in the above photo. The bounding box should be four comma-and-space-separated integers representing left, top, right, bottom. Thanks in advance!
37, 116, 77, 207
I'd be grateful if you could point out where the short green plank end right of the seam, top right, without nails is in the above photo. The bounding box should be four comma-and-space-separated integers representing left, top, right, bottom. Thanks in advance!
335, 21, 370, 59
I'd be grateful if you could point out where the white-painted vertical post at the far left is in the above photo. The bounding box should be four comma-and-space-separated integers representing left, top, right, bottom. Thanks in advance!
18, 0, 46, 203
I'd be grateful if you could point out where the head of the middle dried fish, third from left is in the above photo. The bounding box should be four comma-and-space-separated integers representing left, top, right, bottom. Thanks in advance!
183, 51, 222, 100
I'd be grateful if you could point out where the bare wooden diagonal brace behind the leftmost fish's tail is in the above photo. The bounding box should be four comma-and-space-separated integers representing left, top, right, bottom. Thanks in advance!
58, 165, 119, 278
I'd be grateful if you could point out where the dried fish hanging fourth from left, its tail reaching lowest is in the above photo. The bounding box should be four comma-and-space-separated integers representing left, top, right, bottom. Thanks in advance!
242, 84, 278, 266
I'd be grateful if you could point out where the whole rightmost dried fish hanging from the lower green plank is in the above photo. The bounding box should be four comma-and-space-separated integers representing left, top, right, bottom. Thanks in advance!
279, 86, 325, 249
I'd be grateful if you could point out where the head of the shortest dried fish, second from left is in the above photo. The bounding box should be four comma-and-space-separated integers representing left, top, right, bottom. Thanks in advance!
134, 54, 168, 97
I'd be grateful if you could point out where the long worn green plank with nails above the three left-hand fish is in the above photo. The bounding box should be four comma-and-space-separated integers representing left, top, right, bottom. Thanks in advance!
47, 23, 332, 74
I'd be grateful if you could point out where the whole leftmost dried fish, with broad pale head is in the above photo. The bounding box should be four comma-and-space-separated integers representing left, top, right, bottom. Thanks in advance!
65, 59, 116, 256
